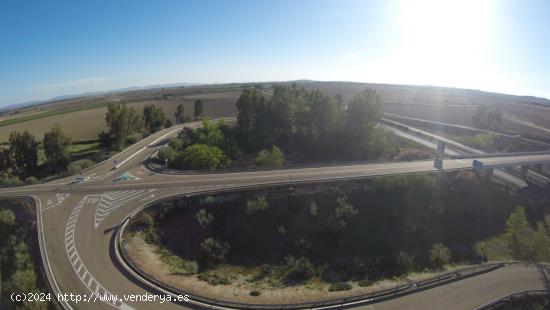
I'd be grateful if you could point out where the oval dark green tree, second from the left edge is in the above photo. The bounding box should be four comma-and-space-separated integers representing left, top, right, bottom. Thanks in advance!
42, 124, 71, 172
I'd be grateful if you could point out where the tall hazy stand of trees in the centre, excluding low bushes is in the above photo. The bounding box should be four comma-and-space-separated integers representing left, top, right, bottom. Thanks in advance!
237, 85, 383, 158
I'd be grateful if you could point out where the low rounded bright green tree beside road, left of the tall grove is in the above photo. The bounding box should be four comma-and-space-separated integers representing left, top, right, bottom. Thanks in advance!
173, 144, 229, 170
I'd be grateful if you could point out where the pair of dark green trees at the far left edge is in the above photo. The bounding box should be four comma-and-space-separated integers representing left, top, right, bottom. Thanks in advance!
0, 124, 71, 179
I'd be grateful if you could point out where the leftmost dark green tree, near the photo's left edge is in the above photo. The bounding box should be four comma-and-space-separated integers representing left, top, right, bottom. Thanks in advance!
9, 130, 38, 179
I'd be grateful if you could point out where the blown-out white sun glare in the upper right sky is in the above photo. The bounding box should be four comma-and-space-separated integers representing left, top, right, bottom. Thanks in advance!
379, 0, 497, 89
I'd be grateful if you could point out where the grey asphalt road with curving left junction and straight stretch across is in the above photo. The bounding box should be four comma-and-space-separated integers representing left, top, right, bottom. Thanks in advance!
0, 122, 550, 309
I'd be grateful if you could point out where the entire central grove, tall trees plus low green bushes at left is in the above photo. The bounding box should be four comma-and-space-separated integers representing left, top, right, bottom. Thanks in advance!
159, 85, 391, 169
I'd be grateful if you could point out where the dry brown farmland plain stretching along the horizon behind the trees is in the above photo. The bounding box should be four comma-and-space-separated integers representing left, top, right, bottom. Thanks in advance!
0, 81, 550, 142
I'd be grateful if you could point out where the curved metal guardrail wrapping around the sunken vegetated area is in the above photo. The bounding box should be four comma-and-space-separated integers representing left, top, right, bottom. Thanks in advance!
114, 188, 515, 309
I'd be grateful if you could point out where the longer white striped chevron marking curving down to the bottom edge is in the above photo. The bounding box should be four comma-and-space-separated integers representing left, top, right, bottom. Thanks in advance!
65, 196, 135, 310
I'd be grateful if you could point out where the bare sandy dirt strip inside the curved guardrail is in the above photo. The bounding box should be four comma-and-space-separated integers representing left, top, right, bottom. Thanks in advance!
124, 234, 466, 304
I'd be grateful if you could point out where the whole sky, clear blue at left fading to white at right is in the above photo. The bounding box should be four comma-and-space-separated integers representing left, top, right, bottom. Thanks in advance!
0, 0, 550, 107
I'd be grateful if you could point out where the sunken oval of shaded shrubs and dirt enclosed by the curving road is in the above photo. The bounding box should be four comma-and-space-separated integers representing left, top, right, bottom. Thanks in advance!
123, 171, 550, 304
